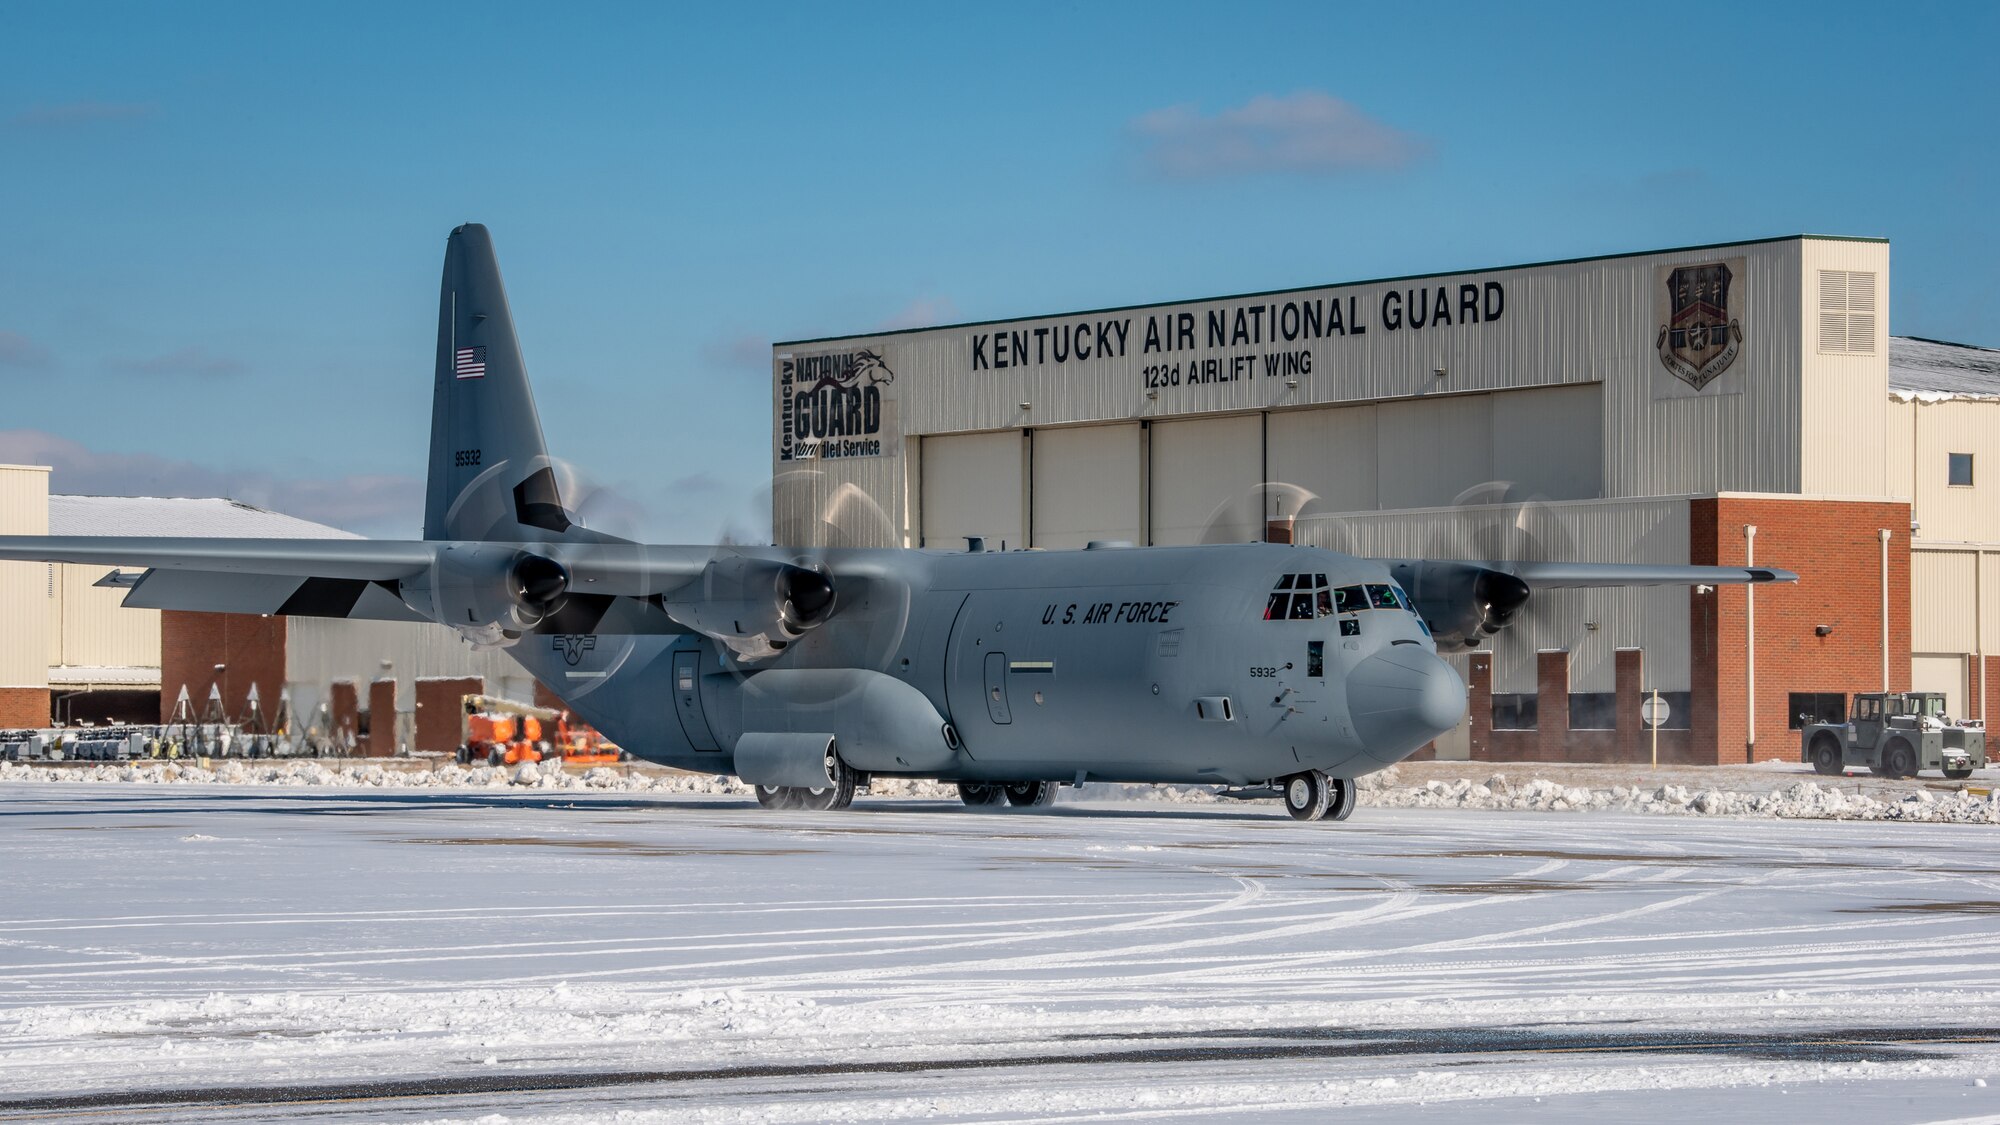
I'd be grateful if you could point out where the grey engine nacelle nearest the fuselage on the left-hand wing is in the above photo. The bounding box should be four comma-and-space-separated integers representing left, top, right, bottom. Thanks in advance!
660, 556, 838, 661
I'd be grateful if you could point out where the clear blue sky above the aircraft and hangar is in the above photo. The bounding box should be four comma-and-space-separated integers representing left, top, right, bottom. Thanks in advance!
0, 2, 2000, 540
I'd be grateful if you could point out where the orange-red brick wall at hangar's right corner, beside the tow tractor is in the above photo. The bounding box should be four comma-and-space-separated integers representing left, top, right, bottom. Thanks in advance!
1688, 496, 1910, 763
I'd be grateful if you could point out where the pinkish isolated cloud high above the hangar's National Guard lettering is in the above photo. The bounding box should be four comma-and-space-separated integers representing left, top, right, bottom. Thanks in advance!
1132, 90, 1430, 180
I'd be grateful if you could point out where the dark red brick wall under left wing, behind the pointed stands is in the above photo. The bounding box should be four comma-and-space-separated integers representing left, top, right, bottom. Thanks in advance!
160, 609, 284, 723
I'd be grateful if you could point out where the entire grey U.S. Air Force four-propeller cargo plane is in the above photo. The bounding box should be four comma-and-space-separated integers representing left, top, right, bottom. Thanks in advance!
0, 224, 1794, 821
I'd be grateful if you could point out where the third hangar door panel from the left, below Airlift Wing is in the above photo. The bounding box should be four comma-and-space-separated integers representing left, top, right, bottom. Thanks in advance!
1148, 414, 1264, 544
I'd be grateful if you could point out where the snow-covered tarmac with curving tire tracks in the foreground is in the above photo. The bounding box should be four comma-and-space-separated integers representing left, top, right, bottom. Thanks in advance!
0, 783, 2000, 1123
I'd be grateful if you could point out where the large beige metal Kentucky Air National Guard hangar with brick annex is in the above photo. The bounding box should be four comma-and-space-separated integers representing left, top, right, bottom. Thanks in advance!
772, 234, 2000, 763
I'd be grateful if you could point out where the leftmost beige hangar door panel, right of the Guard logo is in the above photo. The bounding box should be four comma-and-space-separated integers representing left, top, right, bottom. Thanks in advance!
920, 430, 1028, 550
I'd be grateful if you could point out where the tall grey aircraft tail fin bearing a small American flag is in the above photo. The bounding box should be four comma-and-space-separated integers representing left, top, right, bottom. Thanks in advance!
424, 222, 580, 542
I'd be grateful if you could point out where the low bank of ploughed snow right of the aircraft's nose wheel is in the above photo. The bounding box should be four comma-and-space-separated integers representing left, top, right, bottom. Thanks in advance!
1360, 769, 2000, 825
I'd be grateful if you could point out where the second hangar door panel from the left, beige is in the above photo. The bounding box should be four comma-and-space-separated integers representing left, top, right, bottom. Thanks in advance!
1028, 422, 1146, 550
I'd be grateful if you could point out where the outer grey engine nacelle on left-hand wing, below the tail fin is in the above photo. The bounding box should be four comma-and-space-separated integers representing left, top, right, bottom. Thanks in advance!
398, 542, 570, 649
